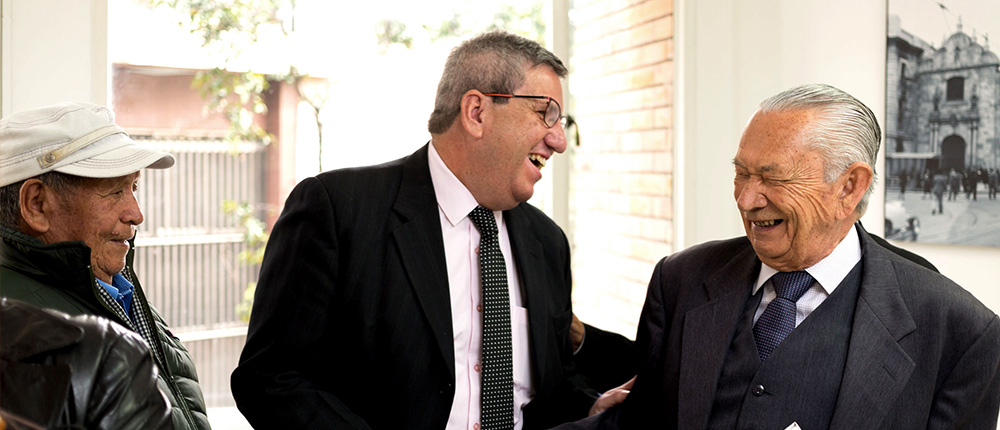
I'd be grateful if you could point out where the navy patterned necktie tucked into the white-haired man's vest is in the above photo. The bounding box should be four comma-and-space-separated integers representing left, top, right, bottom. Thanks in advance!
753, 270, 813, 361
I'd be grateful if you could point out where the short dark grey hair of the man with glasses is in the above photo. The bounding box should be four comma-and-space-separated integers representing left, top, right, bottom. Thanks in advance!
427, 31, 567, 134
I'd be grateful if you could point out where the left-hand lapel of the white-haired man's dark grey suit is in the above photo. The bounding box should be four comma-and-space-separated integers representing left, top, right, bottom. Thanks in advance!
677, 245, 760, 428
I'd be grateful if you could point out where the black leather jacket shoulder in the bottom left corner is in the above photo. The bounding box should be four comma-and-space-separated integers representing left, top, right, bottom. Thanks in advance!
0, 299, 173, 430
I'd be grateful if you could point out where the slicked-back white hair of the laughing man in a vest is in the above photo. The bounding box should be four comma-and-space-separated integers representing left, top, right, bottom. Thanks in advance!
759, 84, 882, 216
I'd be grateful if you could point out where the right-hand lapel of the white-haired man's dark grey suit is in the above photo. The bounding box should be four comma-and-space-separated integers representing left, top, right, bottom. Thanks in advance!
831, 225, 916, 428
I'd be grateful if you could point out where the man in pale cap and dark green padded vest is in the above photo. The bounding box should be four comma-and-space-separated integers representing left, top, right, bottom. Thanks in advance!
0, 103, 209, 429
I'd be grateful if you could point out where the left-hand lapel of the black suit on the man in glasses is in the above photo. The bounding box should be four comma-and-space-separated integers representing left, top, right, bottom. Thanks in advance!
393, 145, 455, 375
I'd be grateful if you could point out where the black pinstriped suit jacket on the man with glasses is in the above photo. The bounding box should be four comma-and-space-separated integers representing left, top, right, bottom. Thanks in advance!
232, 146, 594, 429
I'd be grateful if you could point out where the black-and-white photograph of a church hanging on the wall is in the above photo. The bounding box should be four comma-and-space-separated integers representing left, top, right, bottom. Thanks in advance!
881, 0, 1000, 246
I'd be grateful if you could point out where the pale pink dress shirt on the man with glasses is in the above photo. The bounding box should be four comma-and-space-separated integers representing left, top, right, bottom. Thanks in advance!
430, 142, 534, 430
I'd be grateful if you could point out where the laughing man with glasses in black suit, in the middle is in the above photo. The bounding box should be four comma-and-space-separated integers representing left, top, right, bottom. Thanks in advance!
232, 32, 612, 429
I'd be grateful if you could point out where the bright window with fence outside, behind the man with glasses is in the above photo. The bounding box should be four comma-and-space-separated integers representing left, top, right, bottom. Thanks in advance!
105, 0, 568, 430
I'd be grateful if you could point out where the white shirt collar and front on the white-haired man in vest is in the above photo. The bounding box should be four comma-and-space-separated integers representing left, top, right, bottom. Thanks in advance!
751, 226, 861, 327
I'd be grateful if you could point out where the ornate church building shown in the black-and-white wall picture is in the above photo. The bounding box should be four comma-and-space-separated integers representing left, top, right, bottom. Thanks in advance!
884, 16, 1000, 178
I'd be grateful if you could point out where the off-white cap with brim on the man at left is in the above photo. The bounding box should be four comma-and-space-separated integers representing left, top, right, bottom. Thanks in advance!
0, 102, 174, 186
